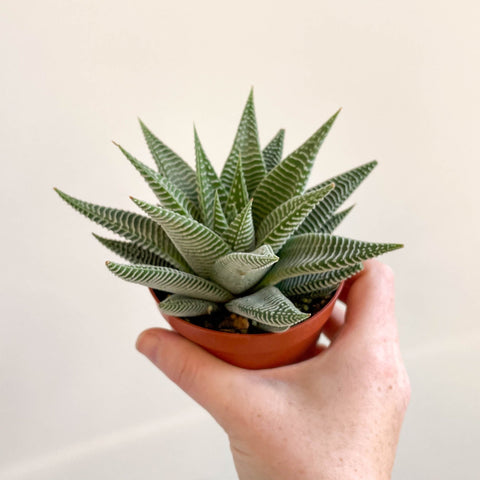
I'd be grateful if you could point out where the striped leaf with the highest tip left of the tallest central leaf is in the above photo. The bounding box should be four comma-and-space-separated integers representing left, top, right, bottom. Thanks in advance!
139, 120, 197, 204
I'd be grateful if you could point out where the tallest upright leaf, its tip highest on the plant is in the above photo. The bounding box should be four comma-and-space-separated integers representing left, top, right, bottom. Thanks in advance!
221, 89, 265, 195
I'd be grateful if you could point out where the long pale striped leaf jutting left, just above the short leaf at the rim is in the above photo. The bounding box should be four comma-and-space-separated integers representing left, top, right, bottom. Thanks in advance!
106, 262, 232, 302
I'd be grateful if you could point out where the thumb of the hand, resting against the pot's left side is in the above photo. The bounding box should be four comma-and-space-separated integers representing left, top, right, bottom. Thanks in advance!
136, 328, 242, 420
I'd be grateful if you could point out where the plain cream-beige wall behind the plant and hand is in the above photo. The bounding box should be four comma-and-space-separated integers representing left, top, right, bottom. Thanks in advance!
0, 0, 480, 480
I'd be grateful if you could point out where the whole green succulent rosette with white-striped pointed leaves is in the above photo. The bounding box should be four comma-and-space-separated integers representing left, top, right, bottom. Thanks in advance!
55, 91, 402, 332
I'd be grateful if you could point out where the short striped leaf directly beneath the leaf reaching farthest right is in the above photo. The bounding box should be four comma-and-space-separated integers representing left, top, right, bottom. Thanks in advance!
276, 263, 363, 296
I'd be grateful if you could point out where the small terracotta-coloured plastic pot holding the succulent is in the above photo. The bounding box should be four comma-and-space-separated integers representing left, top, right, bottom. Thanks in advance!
150, 283, 343, 370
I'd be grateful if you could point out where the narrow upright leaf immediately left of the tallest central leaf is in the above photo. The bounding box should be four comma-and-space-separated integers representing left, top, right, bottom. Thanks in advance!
194, 129, 227, 228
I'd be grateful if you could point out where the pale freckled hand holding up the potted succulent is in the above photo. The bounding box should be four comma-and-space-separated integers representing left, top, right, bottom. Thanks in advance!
137, 260, 410, 480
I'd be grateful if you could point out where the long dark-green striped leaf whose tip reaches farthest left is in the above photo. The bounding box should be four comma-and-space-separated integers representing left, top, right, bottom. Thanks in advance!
55, 189, 191, 272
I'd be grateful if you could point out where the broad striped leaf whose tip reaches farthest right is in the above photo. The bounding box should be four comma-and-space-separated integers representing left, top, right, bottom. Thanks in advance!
260, 233, 403, 286
